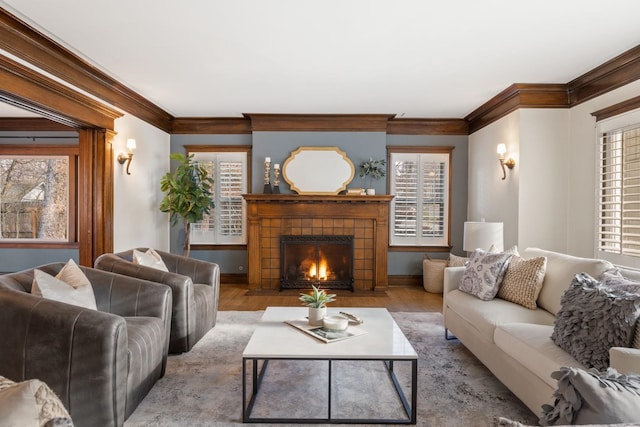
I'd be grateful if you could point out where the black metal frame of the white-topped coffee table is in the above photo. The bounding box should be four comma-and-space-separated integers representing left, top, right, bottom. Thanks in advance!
242, 357, 418, 424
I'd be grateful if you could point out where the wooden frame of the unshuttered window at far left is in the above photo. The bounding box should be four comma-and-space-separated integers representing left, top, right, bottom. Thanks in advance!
0, 144, 80, 249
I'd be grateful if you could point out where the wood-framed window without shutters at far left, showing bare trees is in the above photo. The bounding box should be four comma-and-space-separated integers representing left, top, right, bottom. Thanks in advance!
0, 145, 78, 246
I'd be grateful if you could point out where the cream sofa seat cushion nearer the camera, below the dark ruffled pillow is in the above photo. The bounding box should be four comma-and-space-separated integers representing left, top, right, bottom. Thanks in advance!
494, 323, 584, 388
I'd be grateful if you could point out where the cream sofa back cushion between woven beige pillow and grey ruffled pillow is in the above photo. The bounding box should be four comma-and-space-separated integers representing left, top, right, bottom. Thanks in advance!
522, 248, 613, 315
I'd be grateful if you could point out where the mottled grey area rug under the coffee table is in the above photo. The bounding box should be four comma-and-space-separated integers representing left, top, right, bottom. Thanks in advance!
125, 311, 538, 427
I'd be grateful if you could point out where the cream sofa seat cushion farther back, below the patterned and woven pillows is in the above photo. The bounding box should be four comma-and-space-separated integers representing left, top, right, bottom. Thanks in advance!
446, 290, 555, 342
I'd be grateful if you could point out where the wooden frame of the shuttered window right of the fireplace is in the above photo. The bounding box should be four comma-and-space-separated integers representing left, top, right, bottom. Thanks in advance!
387, 145, 455, 252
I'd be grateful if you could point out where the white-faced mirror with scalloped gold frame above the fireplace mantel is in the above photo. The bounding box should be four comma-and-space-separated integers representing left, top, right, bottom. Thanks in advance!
282, 147, 355, 195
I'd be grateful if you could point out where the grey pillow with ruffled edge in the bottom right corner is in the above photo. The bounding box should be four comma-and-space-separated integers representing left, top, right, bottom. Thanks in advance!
540, 367, 640, 426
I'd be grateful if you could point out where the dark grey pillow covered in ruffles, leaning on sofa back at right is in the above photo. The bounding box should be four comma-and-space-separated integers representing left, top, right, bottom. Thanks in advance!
551, 273, 640, 370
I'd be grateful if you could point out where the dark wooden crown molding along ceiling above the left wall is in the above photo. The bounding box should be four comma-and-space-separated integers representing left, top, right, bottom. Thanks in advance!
0, 8, 173, 132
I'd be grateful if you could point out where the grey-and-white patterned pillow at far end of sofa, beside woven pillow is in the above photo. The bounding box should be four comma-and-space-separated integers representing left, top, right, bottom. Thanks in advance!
459, 249, 511, 301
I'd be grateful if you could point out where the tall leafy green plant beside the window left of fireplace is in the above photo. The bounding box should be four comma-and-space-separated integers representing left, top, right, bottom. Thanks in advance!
160, 153, 215, 256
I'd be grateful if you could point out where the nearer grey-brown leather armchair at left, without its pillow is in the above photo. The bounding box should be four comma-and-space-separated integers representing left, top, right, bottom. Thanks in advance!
0, 263, 171, 426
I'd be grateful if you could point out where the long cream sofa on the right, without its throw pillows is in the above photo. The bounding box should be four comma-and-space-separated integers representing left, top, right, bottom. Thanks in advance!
443, 248, 640, 415
